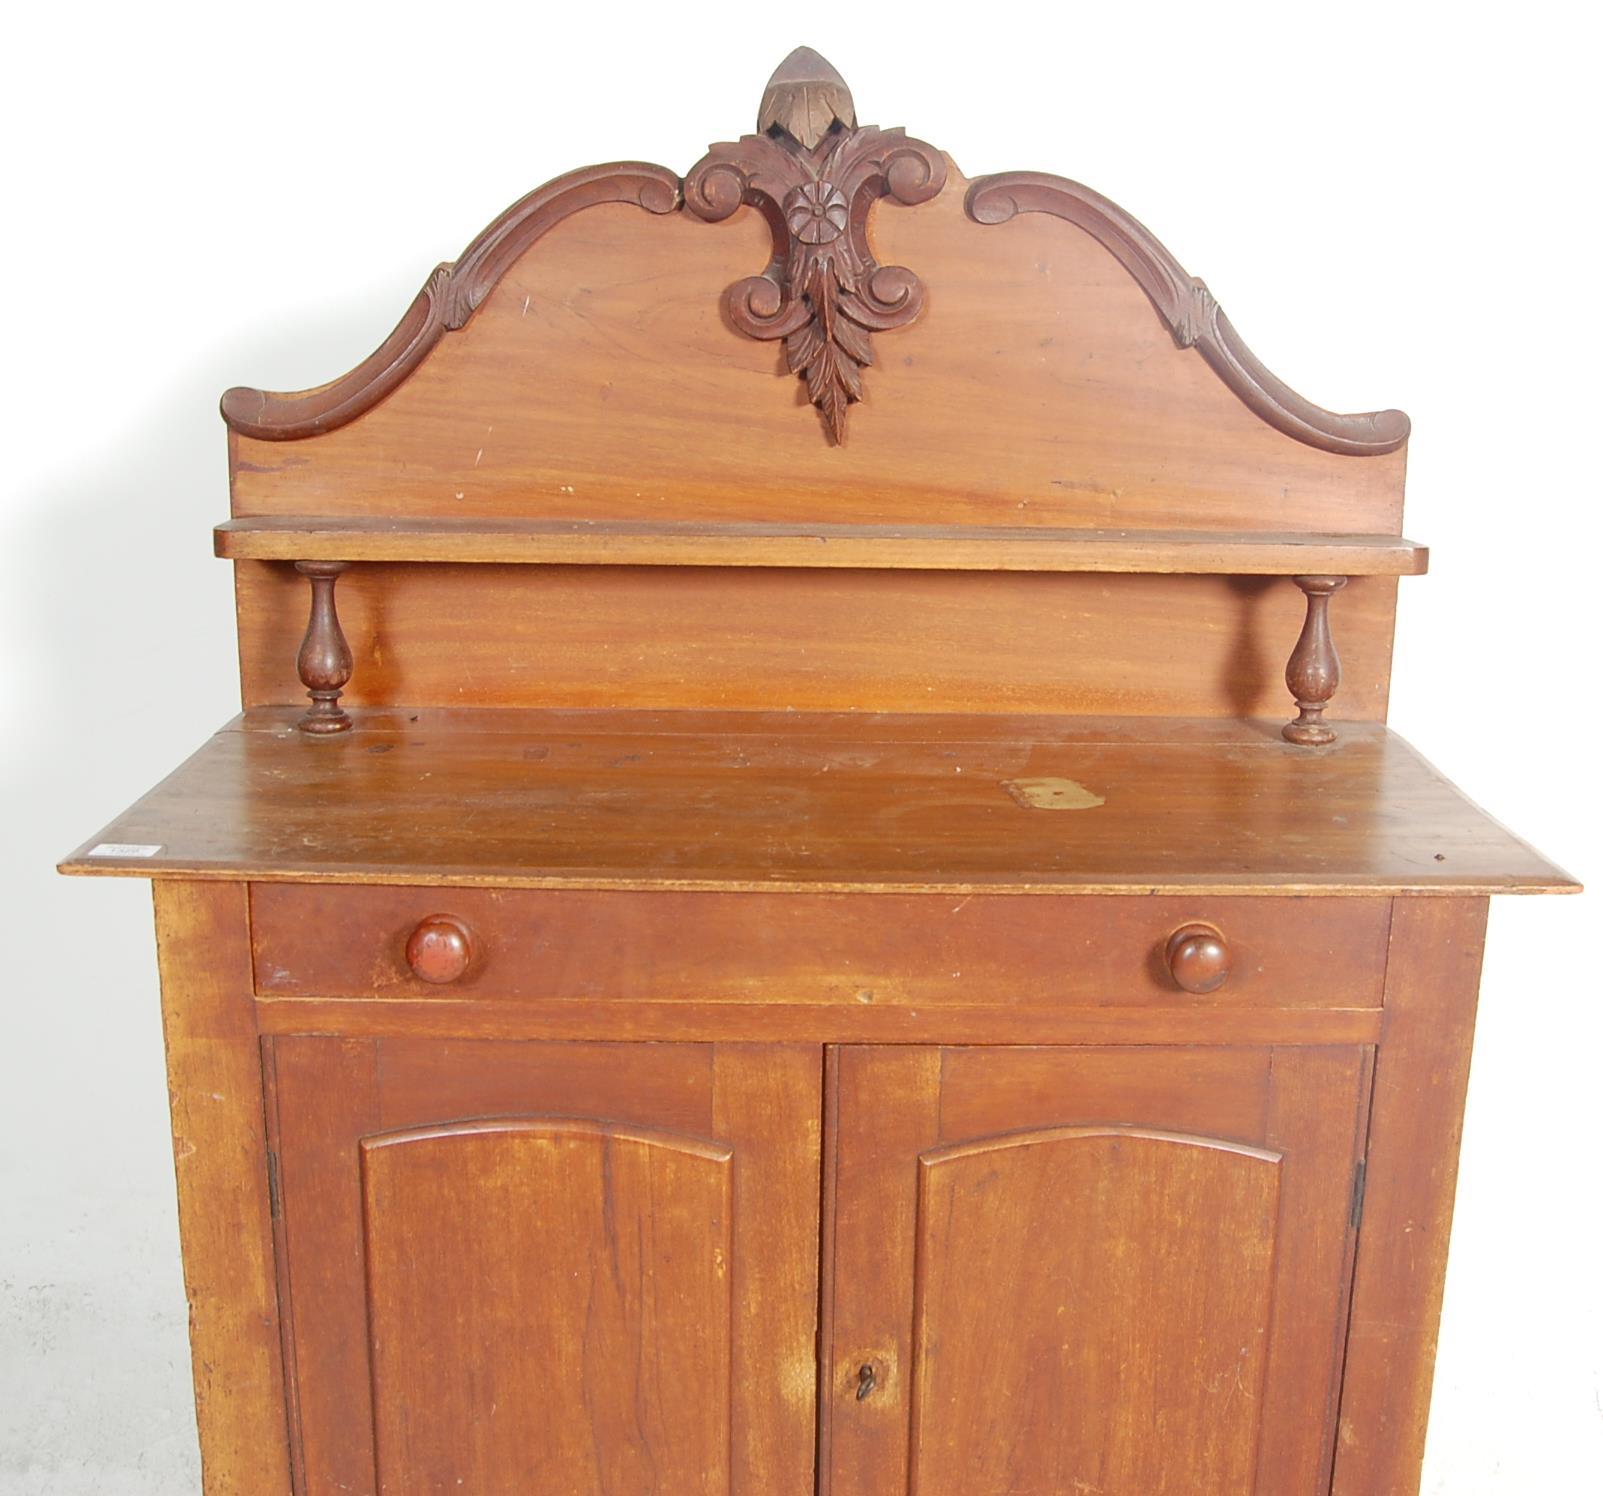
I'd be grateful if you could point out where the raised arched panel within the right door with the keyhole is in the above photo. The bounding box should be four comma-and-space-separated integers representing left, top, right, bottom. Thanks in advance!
912, 1127, 1281, 1496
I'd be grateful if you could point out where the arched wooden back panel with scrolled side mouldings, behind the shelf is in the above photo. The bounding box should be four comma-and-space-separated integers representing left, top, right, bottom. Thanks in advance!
224, 51, 1406, 717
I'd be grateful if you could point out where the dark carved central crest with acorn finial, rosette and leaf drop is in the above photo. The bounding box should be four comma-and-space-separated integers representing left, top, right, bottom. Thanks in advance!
684, 46, 946, 443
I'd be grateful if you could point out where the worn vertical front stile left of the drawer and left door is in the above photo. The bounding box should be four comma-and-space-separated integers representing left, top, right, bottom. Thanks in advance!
155, 880, 290, 1496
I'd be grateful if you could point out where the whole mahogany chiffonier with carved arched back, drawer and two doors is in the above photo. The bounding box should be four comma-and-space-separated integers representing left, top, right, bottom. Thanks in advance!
63, 50, 1574, 1496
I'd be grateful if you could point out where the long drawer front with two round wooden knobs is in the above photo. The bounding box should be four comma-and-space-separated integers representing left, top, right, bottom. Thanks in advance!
250, 883, 1391, 1009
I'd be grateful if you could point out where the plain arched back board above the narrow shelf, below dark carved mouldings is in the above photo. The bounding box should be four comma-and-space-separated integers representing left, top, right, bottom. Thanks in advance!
232, 177, 1404, 534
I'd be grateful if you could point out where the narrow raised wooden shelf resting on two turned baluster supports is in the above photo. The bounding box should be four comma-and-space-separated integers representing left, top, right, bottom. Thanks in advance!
216, 515, 1430, 577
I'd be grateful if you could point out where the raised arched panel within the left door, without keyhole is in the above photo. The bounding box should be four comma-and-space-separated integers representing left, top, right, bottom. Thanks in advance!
359, 1118, 733, 1496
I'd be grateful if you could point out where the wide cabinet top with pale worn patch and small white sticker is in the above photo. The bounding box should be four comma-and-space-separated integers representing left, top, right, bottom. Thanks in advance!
63, 709, 1576, 895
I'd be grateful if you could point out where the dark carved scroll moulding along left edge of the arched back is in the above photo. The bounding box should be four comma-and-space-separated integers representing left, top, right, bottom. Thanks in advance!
223, 162, 680, 441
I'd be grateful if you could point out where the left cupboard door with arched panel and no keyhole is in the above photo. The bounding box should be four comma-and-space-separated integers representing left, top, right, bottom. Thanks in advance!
268, 1037, 819, 1496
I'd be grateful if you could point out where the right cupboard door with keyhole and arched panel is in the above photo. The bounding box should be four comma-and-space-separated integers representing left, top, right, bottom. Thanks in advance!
822, 1047, 1369, 1496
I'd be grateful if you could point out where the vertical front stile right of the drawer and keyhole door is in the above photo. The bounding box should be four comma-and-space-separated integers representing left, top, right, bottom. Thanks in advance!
1330, 898, 1486, 1496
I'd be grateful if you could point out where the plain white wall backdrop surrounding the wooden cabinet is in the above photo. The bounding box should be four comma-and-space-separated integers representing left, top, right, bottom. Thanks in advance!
0, 0, 1603, 1496
